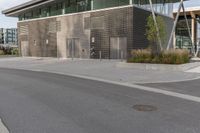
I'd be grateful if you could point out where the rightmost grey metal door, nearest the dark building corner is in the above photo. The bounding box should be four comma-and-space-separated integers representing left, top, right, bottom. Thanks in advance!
110, 37, 127, 59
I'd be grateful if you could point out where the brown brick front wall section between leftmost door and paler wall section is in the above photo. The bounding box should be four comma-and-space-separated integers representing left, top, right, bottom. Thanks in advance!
18, 18, 57, 57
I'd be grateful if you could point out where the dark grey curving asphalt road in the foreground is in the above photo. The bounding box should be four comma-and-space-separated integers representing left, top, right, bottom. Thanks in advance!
0, 69, 200, 133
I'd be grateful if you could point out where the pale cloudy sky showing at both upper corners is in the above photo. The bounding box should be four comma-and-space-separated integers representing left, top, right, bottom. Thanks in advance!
0, 0, 200, 28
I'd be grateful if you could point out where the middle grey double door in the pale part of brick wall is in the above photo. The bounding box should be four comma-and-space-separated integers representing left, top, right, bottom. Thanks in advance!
67, 38, 80, 58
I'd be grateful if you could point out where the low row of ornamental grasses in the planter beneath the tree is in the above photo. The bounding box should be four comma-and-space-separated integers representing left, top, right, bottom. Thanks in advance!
128, 49, 190, 64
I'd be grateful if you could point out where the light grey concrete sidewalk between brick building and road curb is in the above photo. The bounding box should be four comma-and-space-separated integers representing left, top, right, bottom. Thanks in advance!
0, 57, 200, 84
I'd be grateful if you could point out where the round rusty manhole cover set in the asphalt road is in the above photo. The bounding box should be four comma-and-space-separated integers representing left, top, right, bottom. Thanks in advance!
133, 105, 157, 112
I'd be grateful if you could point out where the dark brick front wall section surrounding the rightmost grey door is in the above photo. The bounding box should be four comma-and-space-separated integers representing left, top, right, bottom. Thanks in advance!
91, 7, 133, 59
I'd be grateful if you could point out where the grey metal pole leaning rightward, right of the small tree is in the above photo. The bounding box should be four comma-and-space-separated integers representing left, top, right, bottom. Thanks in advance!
167, 0, 183, 50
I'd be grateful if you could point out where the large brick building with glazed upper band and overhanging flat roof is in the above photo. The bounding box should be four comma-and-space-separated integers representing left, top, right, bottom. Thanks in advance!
3, 0, 183, 59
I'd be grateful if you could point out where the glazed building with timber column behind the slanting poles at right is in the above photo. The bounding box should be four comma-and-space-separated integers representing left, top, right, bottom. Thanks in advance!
174, 6, 200, 49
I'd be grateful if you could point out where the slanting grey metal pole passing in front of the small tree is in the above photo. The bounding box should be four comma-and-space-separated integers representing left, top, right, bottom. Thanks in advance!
149, 0, 163, 51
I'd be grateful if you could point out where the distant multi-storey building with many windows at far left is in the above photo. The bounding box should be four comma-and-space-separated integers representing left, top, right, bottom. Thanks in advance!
0, 28, 18, 46
